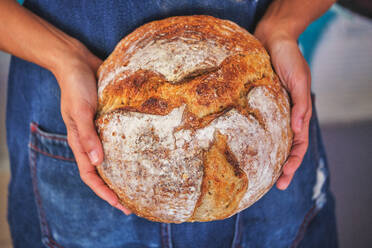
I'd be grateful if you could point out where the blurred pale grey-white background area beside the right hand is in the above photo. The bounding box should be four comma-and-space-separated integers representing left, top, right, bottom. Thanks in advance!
311, 8, 372, 124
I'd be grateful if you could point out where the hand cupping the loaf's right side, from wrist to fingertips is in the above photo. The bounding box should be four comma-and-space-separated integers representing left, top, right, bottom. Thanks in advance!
255, 28, 312, 190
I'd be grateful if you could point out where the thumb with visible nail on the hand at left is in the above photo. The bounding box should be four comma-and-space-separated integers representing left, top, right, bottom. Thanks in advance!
72, 104, 103, 165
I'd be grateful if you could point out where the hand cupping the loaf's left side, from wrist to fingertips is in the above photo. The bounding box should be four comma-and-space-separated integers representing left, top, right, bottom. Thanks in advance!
53, 43, 131, 215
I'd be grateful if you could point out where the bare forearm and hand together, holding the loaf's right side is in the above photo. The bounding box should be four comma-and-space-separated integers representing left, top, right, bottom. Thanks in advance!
255, 0, 335, 190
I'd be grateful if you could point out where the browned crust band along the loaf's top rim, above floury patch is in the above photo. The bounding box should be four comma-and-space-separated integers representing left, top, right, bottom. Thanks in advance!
97, 15, 266, 80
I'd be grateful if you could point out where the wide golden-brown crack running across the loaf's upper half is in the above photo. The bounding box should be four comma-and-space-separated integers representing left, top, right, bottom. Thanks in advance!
98, 53, 274, 128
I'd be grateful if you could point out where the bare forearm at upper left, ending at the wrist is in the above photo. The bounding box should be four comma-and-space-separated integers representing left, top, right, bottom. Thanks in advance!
0, 0, 87, 72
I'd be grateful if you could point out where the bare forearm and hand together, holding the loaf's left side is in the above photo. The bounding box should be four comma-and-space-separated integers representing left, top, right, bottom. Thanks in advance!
0, 0, 130, 214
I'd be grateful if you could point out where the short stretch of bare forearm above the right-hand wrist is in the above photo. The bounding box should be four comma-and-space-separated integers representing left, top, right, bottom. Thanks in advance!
255, 0, 336, 45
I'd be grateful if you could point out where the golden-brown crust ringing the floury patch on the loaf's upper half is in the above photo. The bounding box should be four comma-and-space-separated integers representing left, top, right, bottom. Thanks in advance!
98, 16, 275, 123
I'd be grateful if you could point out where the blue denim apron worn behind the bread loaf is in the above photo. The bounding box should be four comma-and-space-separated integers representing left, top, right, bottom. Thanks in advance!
7, 0, 337, 248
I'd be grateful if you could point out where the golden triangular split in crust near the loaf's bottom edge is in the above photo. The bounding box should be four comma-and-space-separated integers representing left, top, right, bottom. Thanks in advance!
188, 132, 248, 221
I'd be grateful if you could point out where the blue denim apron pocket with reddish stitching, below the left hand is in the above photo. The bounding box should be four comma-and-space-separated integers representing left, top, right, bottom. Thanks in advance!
29, 123, 160, 248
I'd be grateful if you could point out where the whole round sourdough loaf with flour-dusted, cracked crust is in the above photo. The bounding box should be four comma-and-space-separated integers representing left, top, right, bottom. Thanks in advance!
96, 15, 292, 223
